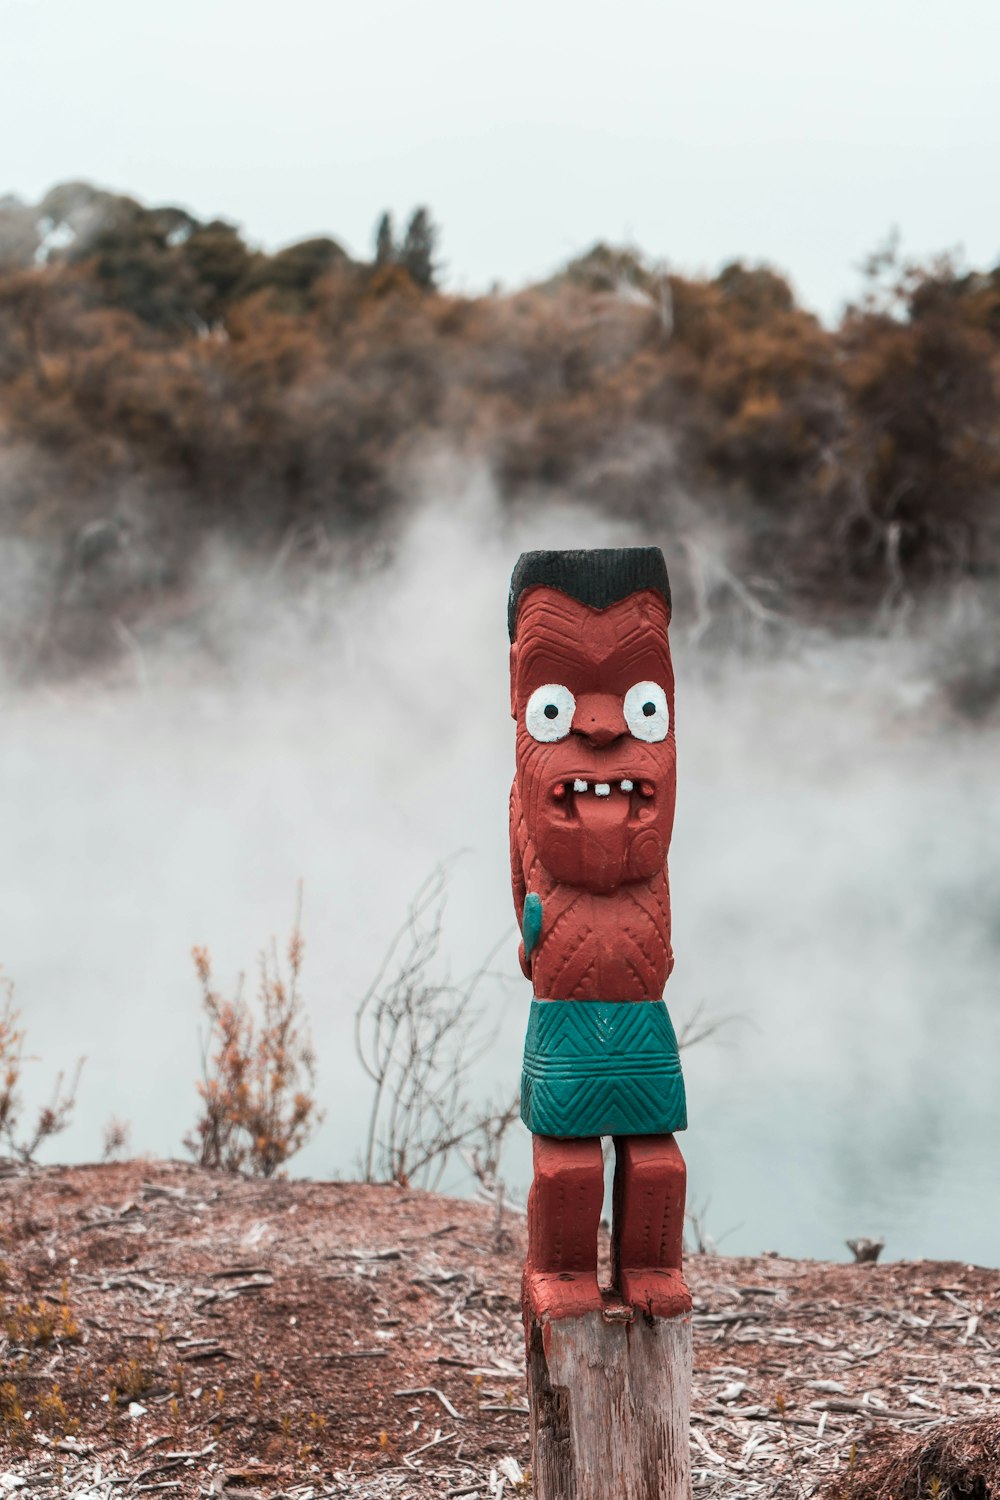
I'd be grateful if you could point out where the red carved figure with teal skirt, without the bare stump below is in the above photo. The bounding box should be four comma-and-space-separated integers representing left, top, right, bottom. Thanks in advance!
510, 548, 690, 1322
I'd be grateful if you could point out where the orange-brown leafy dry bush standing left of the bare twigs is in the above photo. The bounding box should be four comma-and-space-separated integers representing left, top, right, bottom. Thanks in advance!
184, 888, 322, 1178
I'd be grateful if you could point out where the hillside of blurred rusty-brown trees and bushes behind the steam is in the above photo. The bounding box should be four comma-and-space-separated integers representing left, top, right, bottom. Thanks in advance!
0, 183, 1000, 681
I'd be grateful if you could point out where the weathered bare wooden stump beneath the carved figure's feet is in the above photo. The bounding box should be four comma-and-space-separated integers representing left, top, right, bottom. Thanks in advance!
525, 1299, 691, 1500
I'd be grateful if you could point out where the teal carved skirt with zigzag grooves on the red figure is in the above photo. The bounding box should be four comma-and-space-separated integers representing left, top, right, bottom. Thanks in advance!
520, 999, 688, 1137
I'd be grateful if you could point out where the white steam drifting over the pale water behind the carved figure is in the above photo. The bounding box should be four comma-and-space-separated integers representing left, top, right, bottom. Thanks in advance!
0, 462, 1000, 1265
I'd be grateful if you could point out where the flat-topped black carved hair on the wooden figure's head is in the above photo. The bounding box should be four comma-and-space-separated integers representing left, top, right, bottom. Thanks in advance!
507, 548, 670, 641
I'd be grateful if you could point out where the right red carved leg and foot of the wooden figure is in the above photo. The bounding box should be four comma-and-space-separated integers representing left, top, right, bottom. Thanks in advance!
612, 1136, 691, 1317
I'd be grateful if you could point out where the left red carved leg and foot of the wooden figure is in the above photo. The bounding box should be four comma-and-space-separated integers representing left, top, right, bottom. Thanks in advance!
523, 1136, 604, 1322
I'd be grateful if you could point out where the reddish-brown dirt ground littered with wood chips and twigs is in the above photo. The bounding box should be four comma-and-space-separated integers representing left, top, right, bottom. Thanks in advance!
0, 1161, 1000, 1500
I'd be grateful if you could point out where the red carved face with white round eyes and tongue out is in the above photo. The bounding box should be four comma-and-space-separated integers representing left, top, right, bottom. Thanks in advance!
511, 587, 676, 893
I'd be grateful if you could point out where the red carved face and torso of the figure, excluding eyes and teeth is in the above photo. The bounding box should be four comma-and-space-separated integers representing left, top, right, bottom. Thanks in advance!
510, 588, 676, 1001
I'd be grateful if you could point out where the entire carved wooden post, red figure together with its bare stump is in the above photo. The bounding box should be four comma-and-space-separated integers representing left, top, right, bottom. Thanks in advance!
508, 548, 691, 1500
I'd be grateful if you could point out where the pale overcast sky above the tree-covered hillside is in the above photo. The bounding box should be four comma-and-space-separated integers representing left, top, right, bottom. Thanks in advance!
0, 0, 1000, 318
